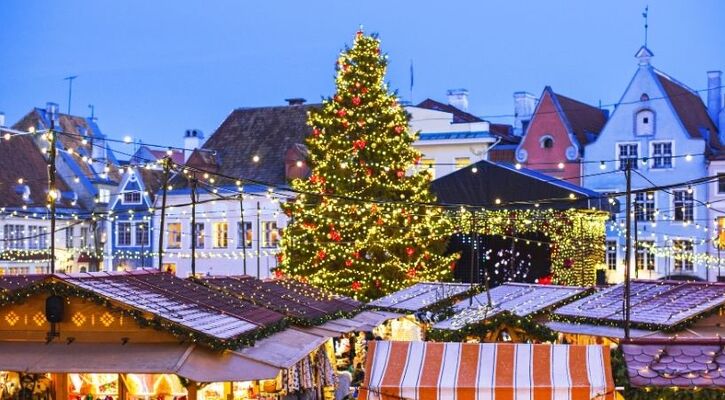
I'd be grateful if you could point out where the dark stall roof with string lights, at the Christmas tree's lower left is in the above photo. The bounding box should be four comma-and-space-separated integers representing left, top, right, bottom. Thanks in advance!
201, 275, 362, 322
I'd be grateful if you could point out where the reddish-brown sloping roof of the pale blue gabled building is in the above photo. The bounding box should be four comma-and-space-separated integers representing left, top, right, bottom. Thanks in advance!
654, 70, 722, 150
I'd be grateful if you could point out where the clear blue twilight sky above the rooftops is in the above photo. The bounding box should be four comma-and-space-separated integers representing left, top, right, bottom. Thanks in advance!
0, 0, 725, 152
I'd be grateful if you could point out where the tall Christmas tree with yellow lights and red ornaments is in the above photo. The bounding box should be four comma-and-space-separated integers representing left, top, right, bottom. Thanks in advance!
278, 32, 455, 300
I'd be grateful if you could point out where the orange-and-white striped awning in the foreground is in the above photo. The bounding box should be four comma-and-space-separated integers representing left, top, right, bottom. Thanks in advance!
359, 341, 614, 400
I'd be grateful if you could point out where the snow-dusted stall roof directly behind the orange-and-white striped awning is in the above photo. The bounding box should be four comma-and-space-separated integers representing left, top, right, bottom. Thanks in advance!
433, 282, 588, 329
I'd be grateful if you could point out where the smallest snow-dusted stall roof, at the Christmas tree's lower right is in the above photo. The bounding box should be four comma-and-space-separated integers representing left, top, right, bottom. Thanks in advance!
368, 282, 471, 312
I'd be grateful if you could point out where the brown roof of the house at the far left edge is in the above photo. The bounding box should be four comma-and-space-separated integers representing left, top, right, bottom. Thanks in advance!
0, 129, 76, 208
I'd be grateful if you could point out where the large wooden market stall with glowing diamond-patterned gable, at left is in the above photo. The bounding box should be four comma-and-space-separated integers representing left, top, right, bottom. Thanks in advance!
0, 271, 335, 400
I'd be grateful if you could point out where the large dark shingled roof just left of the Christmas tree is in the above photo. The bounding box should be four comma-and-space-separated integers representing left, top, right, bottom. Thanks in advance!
189, 104, 320, 185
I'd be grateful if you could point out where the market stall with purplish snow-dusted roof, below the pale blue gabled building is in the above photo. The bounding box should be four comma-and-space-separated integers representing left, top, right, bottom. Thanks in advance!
546, 280, 725, 344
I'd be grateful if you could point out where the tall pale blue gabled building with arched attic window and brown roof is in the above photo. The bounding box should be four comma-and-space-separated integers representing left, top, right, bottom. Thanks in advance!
583, 47, 721, 282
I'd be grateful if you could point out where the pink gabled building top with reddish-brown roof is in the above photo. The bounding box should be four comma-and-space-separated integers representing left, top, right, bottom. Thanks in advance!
516, 86, 607, 185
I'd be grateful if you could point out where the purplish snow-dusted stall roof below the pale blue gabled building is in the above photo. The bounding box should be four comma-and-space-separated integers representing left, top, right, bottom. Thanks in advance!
554, 280, 725, 330
